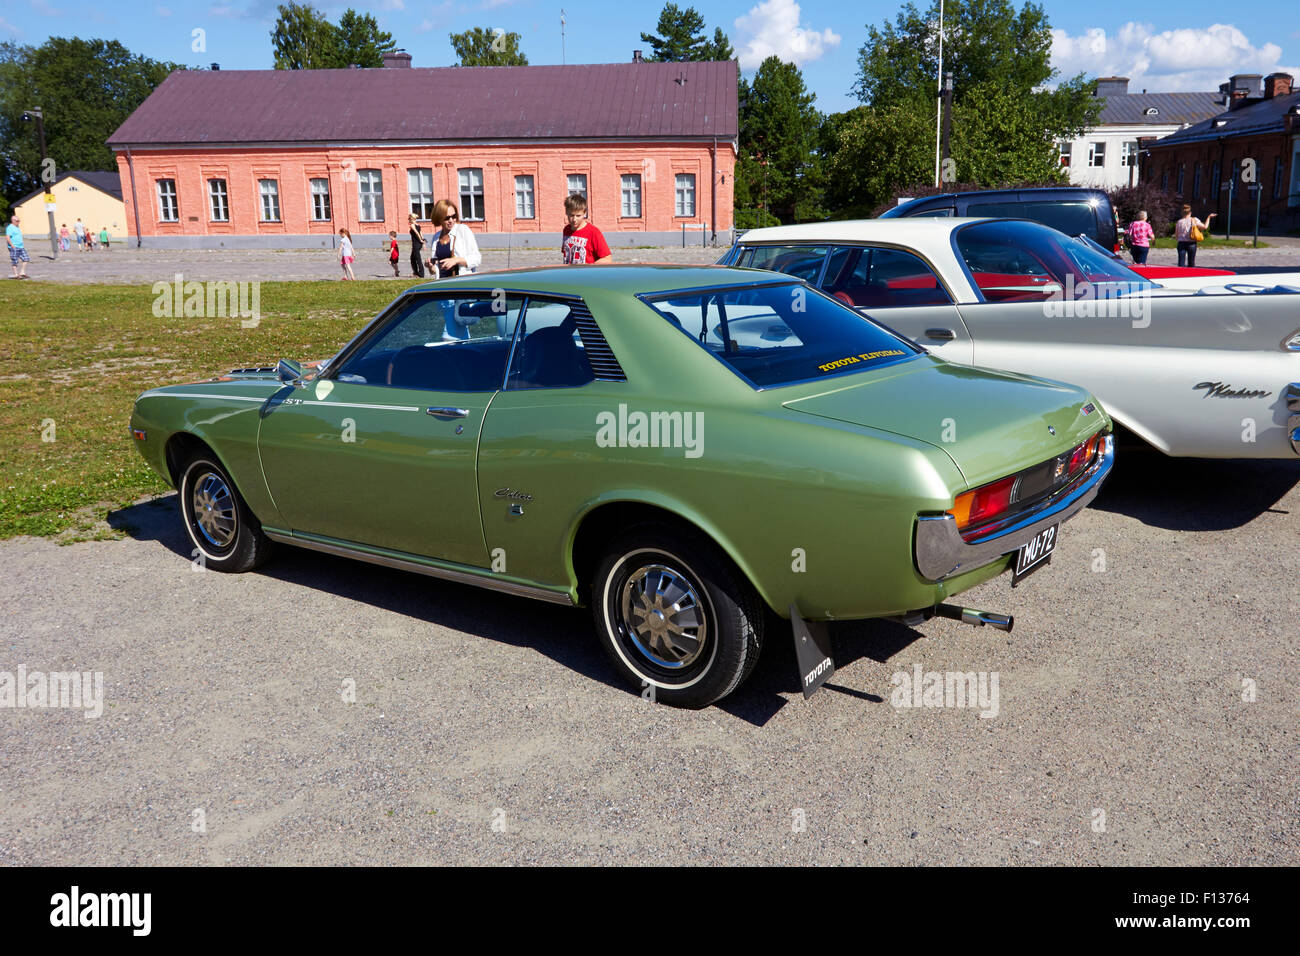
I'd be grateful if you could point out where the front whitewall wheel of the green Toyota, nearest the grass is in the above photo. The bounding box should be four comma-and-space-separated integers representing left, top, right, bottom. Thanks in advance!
179, 453, 272, 572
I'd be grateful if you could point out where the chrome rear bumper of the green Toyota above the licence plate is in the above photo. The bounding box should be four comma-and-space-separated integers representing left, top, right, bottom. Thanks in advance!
914, 434, 1115, 581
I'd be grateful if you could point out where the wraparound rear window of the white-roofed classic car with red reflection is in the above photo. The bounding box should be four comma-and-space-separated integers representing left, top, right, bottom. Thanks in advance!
954, 220, 1156, 300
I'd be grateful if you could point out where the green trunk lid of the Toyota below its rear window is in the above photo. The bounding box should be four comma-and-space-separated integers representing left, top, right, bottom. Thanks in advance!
784, 362, 1109, 488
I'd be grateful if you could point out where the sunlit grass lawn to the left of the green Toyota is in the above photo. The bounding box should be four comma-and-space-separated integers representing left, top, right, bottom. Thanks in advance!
0, 281, 418, 541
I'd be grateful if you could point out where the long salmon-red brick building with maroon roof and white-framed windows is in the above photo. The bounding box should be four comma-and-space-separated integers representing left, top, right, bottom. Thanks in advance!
108, 55, 738, 247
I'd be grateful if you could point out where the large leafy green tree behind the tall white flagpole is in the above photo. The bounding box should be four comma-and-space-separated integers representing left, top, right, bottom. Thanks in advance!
823, 0, 1101, 213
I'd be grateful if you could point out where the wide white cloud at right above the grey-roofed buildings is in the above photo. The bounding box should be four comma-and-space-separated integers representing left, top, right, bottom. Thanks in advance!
1052, 21, 1297, 92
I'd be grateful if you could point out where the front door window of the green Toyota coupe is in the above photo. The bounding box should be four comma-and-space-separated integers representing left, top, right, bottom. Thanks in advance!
333, 294, 524, 392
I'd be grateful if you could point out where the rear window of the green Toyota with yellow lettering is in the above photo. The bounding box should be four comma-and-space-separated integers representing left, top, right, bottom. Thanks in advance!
644, 282, 920, 388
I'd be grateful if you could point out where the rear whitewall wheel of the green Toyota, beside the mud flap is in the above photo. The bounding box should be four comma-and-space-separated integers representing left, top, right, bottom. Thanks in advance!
592, 525, 763, 708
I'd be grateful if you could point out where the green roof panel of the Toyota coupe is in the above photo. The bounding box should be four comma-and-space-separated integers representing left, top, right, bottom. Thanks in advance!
410, 264, 798, 295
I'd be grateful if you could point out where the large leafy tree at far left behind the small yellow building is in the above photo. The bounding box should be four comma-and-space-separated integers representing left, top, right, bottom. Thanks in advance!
0, 36, 185, 208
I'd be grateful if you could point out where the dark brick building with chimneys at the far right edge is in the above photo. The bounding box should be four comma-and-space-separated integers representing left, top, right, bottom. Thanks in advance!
1141, 73, 1300, 232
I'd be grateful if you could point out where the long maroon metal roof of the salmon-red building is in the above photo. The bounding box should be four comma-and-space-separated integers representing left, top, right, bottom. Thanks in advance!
108, 61, 738, 148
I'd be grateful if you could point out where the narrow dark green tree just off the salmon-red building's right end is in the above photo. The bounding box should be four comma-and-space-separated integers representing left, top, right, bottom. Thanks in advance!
736, 56, 822, 221
